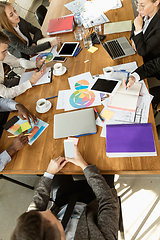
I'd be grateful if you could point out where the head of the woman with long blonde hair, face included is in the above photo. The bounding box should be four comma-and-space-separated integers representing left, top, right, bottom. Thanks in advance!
0, 1, 26, 43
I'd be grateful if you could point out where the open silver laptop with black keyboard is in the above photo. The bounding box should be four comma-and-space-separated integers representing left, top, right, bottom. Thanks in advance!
96, 30, 135, 60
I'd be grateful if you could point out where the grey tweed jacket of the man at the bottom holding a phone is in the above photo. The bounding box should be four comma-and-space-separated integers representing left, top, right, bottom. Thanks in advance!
28, 165, 119, 240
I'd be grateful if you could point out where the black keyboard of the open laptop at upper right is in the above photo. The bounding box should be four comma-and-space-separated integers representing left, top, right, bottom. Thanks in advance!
103, 40, 125, 58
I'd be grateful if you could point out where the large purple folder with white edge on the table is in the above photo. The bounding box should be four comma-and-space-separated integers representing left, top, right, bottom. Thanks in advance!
106, 123, 157, 157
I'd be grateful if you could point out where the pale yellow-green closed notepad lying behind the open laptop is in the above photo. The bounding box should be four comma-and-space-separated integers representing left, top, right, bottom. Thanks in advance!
104, 20, 132, 34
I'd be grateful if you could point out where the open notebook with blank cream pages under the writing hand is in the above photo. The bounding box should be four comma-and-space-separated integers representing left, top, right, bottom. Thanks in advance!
108, 83, 142, 112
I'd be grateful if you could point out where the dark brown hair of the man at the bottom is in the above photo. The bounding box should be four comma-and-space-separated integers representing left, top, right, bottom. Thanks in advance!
10, 210, 61, 240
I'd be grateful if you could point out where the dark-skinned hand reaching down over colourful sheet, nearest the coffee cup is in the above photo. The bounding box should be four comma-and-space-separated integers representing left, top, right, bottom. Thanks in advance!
15, 103, 38, 124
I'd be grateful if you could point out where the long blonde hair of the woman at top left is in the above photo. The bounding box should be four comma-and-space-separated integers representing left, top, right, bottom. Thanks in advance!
0, 1, 26, 44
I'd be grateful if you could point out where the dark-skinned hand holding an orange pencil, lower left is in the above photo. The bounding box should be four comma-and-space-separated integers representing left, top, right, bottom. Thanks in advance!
6, 131, 29, 157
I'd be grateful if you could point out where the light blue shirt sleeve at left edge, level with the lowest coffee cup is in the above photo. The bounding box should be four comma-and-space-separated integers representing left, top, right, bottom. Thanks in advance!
0, 98, 17, 112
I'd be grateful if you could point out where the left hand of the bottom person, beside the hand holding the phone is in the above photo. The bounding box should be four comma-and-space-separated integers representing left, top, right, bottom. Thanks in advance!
47, 156, 68, 175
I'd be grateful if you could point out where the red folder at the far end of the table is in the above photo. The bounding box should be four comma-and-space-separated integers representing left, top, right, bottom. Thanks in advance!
47, 15, 74, 35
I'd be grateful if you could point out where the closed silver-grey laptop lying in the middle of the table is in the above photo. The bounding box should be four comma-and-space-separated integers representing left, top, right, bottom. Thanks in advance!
53, 108, 97, 139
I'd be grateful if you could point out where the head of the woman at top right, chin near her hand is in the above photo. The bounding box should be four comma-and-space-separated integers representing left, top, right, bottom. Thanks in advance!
135, 0, 160, 17
